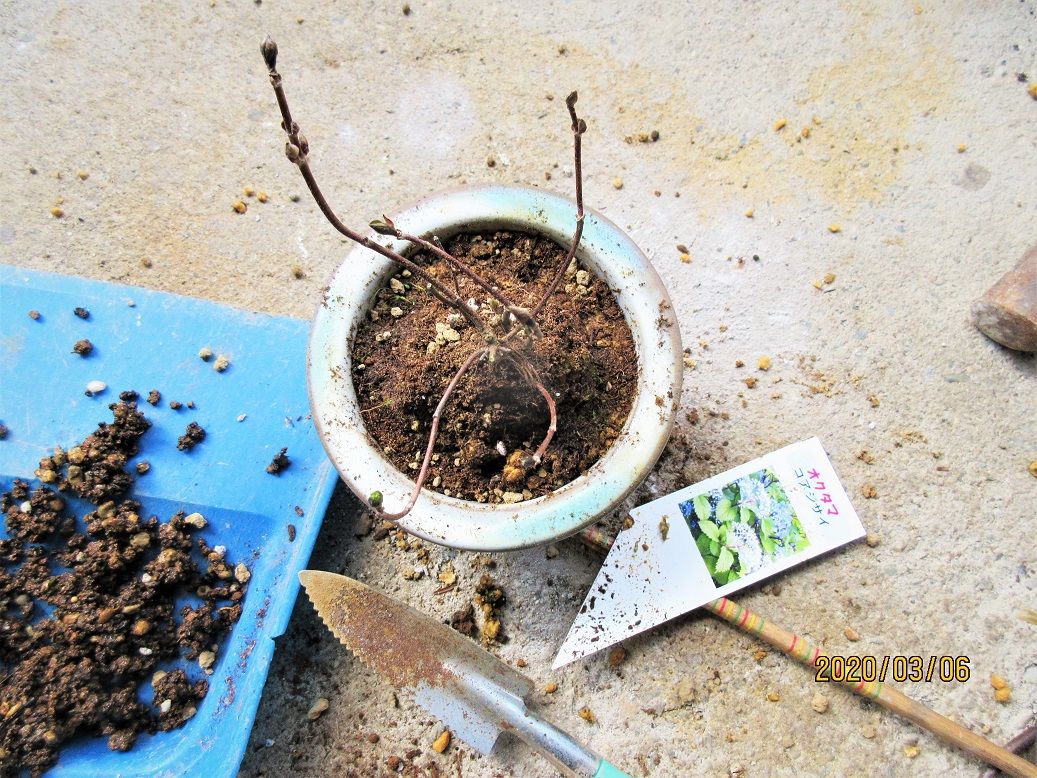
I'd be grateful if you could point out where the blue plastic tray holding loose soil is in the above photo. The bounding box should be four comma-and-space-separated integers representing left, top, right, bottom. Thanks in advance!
0, 265, 337, 777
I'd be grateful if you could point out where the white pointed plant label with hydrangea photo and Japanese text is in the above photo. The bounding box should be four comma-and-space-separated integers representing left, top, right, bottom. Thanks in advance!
554, 438, 864, 668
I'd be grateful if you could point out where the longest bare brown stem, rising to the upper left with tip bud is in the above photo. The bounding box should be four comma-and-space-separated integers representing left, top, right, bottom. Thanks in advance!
260, 37, 486, 333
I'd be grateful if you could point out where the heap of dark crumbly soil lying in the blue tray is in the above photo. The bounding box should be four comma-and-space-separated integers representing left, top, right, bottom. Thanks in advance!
0, 402, 249, 776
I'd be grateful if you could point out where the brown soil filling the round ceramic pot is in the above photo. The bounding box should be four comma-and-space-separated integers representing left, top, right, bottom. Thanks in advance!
353, 231, 638, 502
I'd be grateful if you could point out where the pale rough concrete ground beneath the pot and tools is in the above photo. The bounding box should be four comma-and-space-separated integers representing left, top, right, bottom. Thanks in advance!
0, 0, 1037, 778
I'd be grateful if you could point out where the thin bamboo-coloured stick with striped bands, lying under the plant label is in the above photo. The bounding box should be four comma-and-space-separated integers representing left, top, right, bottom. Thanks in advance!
580, 527, 1037, 778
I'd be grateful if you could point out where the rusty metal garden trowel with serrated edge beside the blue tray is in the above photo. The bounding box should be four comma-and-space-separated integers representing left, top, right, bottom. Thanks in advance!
299, 569, 629, 778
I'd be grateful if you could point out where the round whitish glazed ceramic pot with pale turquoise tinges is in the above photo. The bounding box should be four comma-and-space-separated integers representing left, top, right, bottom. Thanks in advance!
308, 186, 683, 551
